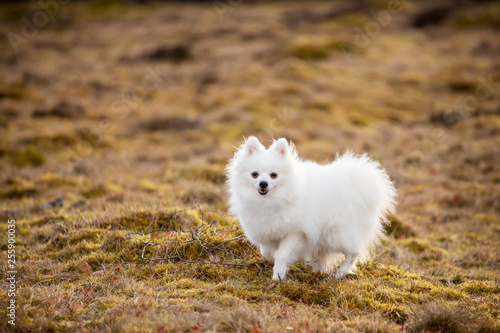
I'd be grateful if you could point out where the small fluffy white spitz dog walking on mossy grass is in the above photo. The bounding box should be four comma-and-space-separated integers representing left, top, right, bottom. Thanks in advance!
227, 137, 396, 279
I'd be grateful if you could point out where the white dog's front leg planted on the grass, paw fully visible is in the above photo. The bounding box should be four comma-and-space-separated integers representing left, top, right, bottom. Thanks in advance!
273, 233, 307, 280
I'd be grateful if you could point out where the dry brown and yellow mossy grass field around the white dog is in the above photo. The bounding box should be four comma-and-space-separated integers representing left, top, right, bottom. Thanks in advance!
0, 0, 500, 333
